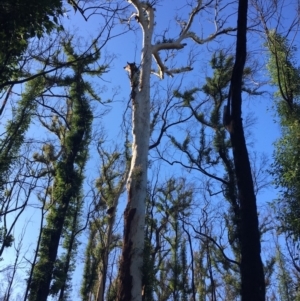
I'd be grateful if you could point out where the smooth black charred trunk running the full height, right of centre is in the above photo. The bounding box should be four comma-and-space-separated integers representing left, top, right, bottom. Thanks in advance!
228, 0, 265, 301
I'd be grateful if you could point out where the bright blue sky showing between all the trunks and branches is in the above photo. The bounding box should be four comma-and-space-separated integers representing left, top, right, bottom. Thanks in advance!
0, 0, 299, 300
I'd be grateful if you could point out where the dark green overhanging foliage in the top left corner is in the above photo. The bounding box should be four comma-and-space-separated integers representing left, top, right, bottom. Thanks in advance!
0, 0, 63, 84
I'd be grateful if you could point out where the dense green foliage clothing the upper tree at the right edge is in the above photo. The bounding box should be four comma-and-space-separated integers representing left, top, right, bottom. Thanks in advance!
266, 31, 300, 239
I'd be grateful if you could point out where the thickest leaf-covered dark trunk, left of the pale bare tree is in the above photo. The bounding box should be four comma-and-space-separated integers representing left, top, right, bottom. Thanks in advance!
28, 52, 93, 301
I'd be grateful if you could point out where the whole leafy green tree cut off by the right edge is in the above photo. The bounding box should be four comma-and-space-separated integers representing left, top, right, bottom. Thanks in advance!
265, 16, 300, 300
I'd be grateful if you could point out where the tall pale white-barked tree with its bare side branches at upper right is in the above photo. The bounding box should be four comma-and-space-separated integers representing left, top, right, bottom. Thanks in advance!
117, 0, 234, 301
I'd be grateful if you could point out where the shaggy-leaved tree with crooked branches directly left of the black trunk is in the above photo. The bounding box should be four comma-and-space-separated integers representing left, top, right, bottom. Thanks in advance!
163, 50, 266, 296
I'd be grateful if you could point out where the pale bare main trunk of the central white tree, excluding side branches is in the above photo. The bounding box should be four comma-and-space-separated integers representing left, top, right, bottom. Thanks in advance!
117, 1, 153, 301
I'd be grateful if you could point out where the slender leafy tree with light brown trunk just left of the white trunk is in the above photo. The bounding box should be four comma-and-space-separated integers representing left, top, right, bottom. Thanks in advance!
81, 142, 130, 301
